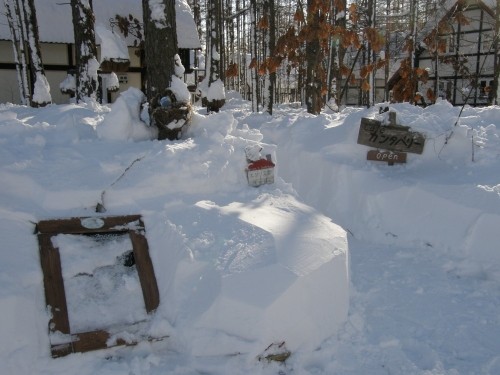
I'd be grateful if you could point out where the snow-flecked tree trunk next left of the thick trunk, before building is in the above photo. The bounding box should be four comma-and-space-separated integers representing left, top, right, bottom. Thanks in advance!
71, 0, 99, 102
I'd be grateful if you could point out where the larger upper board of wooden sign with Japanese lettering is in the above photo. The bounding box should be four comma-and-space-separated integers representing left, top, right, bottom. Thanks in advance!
358, 118, 425, 154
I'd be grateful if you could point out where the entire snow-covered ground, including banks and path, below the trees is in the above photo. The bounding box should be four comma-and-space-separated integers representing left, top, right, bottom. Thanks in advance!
0, 91, 500, 375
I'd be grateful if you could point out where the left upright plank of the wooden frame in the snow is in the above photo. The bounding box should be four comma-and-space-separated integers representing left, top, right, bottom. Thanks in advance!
38, 234, 70, 334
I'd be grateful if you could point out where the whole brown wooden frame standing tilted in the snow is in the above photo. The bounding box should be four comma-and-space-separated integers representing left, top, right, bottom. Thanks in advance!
36, 215, 160, 357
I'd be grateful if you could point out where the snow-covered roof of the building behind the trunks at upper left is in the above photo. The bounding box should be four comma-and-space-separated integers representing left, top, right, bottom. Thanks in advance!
0, 0, 200, 49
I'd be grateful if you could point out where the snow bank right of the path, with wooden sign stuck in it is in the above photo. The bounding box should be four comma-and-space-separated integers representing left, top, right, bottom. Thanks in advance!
262, 101, 500, 279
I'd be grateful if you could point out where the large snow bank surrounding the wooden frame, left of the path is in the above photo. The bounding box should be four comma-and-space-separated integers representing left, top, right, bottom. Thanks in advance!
0, 98, 349, 374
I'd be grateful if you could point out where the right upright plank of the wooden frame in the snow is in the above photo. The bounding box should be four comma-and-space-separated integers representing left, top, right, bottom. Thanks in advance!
129, 230, 160, 313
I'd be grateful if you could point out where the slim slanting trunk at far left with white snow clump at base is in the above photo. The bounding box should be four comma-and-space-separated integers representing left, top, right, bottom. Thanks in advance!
22, 0, 52, 107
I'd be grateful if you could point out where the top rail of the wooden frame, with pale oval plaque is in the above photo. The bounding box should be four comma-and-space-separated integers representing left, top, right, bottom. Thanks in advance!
37, 215, 144, 234
